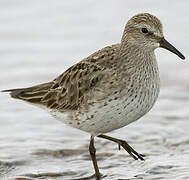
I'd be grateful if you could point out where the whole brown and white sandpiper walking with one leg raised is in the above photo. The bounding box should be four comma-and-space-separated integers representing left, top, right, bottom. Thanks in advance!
2, 13, 185, 180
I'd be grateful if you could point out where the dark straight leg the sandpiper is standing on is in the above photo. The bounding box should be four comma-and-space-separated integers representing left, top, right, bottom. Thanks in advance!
89, 136, 101, 180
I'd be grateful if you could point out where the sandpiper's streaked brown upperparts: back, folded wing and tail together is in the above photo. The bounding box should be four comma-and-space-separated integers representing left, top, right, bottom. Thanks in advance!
1, 44, 119, 111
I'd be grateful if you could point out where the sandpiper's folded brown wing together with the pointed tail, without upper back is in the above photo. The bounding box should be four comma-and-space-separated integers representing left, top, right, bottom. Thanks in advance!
2, 62, 103, 110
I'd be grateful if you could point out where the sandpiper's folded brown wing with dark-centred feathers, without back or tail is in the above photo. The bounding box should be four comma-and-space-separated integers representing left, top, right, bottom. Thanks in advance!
41, 62, 103, 110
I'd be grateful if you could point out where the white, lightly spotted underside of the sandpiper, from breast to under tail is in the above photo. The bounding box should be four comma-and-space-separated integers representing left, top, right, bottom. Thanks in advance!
51, 83, 159, 135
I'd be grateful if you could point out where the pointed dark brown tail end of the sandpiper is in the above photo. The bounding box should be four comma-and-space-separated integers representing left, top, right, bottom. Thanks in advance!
0, 82, 53, 104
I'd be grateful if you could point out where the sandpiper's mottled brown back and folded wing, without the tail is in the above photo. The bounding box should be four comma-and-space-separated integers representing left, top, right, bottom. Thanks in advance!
41, 44, 120, 111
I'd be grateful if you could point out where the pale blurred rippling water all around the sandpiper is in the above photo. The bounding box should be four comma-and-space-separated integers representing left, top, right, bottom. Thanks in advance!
0, 0, 189, 180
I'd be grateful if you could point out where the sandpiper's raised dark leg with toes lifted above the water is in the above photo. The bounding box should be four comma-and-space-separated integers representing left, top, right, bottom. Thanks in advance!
97, 134, 144, 161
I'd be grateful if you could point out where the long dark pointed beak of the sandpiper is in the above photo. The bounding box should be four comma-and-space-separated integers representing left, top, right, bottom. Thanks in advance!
159, 38, 185, 59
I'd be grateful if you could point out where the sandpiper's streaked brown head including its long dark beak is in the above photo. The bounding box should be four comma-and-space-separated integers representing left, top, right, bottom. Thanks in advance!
122, 13, 185, 59
